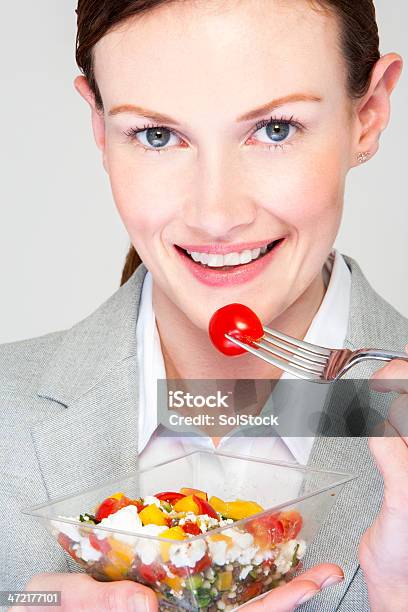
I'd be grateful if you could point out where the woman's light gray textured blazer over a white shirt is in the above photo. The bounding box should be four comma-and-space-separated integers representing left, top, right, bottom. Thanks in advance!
0, 257, 408, 612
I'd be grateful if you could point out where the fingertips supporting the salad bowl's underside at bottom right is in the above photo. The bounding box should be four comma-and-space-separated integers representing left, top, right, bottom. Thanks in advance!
243, 563, 343, 612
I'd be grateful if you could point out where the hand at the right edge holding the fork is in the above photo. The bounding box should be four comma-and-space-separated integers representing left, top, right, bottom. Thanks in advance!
359, 360, 408, 612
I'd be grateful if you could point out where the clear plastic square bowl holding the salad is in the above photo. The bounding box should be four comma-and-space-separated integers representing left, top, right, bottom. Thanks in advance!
22, 451, 355, 612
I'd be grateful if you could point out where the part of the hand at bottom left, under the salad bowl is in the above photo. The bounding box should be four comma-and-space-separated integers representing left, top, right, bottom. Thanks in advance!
9, 574, 158, 612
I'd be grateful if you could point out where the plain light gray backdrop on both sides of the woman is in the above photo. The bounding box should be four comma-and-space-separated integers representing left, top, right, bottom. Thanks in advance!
0, 0, 408, 342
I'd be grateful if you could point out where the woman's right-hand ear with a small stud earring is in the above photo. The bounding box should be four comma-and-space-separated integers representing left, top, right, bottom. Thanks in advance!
353, 53, 403, 165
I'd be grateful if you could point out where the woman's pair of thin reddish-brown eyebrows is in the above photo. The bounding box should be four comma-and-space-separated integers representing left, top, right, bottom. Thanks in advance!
108, 93, 322, 125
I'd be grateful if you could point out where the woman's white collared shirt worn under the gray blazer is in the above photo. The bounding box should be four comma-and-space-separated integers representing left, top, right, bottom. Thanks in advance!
136, 250, 351, 478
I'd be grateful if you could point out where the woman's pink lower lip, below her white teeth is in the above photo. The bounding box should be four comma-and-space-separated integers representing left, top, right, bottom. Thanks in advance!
175, 238, 286, 287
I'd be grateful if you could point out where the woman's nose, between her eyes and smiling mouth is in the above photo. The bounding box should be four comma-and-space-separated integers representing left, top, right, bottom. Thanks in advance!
183, 151, 256, 239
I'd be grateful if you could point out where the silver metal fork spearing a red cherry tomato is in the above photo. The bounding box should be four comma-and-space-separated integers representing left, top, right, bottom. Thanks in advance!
225, 327, 408, 383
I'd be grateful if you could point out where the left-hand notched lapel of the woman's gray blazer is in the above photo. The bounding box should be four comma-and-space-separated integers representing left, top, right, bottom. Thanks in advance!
31, 265, 147, 498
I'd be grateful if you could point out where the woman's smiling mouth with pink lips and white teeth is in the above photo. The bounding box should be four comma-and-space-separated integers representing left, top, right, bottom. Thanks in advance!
174, 237, 286, 286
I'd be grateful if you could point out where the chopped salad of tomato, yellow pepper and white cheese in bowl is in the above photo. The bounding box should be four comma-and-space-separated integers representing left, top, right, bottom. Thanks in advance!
53, 488, 306, 612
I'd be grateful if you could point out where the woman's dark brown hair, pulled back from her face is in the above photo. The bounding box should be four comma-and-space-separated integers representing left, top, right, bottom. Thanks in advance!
76, 0, 380, 285
